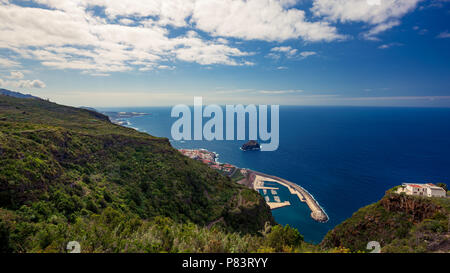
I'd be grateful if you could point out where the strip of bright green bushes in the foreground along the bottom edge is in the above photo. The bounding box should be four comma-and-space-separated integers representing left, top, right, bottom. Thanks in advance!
0, 203, 322, 253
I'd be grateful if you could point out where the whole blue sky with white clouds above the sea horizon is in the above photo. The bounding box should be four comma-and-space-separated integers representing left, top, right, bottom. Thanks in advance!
0, 0, 450, 107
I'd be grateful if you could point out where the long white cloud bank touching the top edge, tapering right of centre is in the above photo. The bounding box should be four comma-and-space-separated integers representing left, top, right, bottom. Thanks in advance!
29, 0, 343, 41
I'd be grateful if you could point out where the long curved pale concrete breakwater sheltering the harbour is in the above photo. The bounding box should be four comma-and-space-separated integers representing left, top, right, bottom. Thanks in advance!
250, 171, 328, 222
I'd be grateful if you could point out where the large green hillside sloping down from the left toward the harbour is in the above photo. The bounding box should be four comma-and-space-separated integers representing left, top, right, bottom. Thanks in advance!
0, 95, 274, 252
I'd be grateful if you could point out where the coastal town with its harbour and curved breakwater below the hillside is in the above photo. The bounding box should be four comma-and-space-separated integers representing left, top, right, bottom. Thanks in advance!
179, 149, 328, 222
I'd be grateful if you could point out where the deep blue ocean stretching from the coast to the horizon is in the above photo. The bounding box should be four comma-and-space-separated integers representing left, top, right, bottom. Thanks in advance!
100, 106, 450, 243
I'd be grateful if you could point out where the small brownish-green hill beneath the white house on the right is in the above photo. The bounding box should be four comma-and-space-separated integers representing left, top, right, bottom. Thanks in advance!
321, 190, 450, 253
